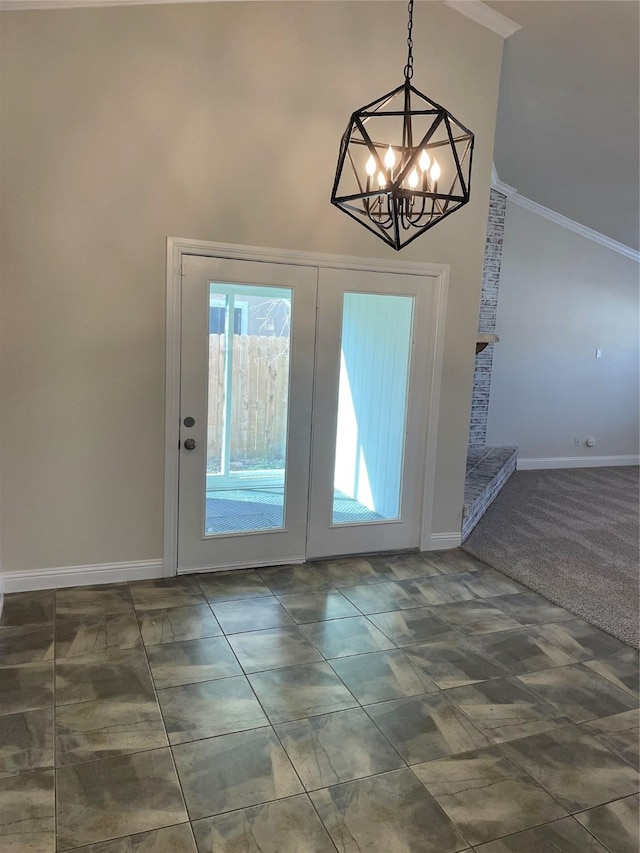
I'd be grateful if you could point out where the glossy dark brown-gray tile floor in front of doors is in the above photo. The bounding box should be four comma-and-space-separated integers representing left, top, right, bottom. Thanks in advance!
0, 551, 640, 853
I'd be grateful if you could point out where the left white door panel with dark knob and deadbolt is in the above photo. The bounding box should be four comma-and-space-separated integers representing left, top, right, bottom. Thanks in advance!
178, 256, 318, 571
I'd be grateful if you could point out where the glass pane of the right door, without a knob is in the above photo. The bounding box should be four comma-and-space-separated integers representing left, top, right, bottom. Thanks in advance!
332, 293, 413, 524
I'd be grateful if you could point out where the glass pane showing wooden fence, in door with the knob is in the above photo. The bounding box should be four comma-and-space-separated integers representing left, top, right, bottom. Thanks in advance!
204, 282, 292, 537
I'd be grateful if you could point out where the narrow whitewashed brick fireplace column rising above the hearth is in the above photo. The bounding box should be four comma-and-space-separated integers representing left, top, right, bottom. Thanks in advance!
469, 189, 507, 447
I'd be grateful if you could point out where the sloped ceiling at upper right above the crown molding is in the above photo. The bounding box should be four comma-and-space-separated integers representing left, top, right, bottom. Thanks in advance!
485, 0, 640, 250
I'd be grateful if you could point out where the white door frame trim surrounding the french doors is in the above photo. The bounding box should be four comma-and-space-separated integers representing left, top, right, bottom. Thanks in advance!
163, 237, 449, 577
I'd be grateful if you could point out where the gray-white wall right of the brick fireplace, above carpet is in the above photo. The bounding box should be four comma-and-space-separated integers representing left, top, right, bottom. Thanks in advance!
487, 202, 639, 463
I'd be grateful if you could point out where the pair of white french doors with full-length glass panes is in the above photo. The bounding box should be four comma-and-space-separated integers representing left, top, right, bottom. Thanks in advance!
177, 250, 435, 572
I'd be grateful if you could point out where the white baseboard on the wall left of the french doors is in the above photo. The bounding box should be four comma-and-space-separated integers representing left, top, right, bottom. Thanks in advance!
2, 560, 163, 593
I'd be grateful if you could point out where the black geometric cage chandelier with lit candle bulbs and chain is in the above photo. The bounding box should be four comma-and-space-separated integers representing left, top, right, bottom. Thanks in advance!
331, 0, 473, 250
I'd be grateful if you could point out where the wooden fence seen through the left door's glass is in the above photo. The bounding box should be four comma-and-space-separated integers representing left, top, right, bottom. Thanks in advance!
207, 335, 289, 463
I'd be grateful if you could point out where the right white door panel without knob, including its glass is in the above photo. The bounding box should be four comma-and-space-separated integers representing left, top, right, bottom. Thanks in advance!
307, 268, 437, 560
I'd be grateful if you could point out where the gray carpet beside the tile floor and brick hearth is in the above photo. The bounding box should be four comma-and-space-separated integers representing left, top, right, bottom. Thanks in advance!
462, 466, 640, 647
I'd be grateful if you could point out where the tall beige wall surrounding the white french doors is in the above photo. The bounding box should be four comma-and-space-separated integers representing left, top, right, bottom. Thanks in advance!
0, 2, 502, 571
